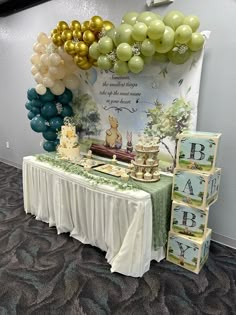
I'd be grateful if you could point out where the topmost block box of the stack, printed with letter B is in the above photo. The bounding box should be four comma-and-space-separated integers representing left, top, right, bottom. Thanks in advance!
176, 131, 221, 173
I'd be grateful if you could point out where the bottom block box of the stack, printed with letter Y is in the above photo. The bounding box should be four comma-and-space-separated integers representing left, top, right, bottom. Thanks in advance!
166, 229, 211, 273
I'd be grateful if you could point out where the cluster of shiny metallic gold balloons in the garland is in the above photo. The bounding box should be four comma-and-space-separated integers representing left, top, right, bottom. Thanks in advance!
51, 16, 114, 70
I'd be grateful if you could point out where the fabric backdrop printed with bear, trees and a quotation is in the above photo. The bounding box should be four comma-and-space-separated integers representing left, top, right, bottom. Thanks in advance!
73, 31, 210, 171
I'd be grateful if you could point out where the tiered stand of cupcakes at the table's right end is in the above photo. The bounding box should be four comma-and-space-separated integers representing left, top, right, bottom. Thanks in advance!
130, 137, 160, 182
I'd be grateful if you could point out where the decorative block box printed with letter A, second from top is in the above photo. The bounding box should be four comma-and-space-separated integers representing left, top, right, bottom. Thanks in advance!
172, 168, 221, 210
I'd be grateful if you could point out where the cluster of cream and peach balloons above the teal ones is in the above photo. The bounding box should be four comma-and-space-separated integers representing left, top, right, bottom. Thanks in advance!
31, 33, 79, 95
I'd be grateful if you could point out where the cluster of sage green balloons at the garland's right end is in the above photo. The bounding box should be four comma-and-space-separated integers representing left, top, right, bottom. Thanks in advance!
89, 11, 204, 75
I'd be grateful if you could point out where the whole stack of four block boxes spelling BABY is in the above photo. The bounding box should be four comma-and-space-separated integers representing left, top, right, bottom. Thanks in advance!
167, 131, 221, 273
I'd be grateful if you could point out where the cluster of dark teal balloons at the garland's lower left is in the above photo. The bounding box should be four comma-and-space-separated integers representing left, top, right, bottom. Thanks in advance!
25, 88, 74, 152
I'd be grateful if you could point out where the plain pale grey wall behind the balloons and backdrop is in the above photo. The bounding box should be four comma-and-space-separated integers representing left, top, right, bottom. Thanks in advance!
0, 0, 236, 247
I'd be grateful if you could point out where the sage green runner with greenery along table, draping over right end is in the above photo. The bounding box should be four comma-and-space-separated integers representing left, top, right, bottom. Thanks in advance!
36, 154, 172, 250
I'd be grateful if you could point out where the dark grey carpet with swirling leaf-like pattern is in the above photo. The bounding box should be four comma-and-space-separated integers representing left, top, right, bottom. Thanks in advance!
0, 163, 236, 315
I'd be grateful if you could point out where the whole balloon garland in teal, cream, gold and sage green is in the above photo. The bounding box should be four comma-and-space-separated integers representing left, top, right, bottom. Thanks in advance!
25, 11, 205, 151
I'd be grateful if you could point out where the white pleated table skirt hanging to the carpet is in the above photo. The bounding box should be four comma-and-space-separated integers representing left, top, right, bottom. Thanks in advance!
23, 156, 165, 277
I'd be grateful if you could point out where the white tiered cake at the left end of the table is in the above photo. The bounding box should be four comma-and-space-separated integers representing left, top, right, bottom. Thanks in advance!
57, 125, 80, 161
